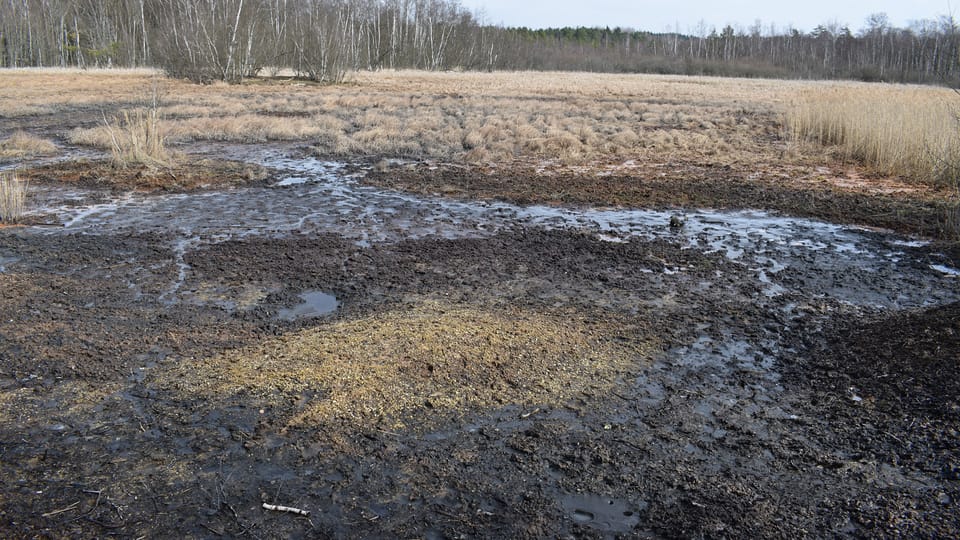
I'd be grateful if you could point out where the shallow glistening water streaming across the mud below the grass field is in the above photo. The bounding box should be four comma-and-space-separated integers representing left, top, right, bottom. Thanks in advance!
22, 148, 960, 311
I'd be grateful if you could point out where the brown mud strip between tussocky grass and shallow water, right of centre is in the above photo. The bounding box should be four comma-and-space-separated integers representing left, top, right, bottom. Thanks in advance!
364, 162, 957, 240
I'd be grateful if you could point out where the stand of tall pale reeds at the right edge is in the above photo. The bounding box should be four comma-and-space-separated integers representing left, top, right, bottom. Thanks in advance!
787, 83, 960, 185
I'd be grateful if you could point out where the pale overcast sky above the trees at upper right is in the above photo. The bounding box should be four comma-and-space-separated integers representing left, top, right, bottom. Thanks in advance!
461, 0, 960, 32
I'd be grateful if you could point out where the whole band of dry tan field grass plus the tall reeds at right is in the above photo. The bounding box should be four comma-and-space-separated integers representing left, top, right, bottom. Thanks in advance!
0, 70, 957, 181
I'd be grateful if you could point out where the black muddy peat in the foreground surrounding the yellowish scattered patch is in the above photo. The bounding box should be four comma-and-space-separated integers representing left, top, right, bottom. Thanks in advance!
0, 150, 960, 538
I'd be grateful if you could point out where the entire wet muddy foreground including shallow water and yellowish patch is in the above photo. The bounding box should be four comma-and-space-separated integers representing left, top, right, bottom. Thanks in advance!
0, 147, 960, 538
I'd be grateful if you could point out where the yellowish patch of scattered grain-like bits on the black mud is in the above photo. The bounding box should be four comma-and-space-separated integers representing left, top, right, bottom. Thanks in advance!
164, 301, 644, 427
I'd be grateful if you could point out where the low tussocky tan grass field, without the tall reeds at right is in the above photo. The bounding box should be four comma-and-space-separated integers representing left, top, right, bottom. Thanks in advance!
0, 71, 803, 165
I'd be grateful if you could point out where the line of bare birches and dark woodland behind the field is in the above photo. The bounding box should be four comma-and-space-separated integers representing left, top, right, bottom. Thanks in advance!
0, 0, 960, 85
